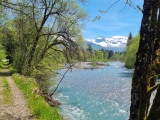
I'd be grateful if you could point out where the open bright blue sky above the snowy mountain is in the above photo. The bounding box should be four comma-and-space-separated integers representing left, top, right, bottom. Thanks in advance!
82, 0, 143, 39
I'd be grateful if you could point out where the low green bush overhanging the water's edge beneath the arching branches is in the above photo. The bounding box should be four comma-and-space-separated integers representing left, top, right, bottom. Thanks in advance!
31, 52, 64, 94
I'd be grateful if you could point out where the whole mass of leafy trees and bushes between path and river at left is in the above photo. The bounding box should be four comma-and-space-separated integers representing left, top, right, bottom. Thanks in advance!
0, 0, 87, 93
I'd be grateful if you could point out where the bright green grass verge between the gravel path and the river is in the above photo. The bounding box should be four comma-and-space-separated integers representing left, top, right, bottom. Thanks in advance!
12, 74, 62, 120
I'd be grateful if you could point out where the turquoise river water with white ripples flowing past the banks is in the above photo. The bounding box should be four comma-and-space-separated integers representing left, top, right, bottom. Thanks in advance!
53, 62, 133, 120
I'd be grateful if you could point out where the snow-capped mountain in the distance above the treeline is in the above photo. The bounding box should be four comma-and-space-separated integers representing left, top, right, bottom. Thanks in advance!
85, 36, 128, 52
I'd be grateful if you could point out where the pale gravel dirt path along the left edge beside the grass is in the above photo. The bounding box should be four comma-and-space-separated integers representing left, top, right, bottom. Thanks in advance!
0, 68, 34, 120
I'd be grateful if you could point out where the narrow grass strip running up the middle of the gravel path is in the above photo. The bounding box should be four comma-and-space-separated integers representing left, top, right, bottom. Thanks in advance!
2, 76, 12, 104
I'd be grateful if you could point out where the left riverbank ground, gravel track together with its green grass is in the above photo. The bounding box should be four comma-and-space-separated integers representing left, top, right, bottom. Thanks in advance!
0, 63, 62, 120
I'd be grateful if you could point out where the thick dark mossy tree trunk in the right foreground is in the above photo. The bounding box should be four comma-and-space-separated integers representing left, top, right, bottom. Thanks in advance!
129, 0, 159, 120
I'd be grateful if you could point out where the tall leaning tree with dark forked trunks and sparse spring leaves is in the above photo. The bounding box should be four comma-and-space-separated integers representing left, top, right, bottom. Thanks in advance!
1, 0, 86, 75
